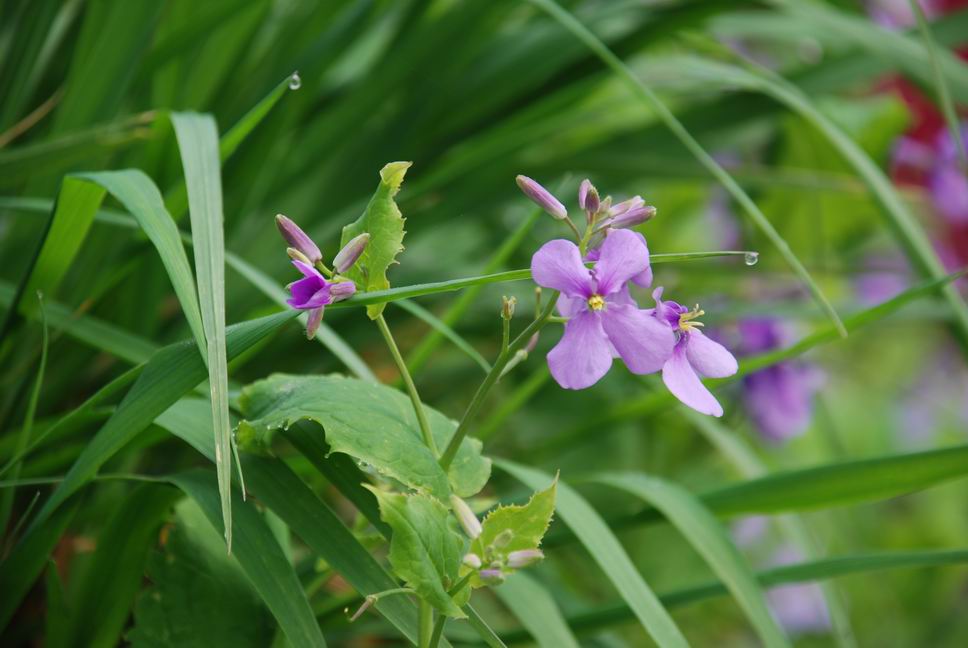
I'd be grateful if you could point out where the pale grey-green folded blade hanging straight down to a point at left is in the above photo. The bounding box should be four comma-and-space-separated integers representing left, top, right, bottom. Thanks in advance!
171, 113, 236, 553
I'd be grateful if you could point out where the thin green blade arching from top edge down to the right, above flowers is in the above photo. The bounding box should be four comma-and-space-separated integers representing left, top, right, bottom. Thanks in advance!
529, 0, 847, 337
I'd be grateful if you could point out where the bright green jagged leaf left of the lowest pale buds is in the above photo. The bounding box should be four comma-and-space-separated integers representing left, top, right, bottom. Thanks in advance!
369, 487, 467, 618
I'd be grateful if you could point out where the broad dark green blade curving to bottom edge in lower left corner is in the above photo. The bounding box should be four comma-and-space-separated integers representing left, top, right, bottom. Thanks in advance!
70, 484, 181, 647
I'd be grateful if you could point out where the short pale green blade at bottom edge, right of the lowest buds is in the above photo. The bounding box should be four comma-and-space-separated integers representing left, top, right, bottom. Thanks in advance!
494, 573, 578, 648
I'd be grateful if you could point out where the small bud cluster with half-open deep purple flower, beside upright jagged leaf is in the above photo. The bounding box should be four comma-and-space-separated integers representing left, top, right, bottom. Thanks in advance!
276, 214, 370, 339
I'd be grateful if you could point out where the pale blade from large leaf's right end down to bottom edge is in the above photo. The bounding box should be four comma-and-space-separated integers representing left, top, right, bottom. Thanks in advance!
494, 459, 689, 647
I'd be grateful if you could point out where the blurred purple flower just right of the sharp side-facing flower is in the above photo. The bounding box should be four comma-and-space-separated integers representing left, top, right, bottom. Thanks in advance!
739, 318, 820, 441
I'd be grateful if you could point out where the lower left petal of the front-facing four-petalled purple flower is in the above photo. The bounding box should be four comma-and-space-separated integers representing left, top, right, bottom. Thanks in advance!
548, 311, 612, 389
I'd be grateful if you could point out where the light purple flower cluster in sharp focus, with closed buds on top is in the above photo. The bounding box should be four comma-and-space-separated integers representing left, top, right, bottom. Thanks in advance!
518, 176, 737, 416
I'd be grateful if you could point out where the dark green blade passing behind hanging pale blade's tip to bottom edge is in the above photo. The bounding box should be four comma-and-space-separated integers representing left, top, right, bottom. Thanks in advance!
171, 470, 326, 648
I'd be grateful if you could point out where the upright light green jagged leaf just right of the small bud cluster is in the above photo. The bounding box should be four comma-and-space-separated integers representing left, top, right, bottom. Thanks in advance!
340, 162, 413, 319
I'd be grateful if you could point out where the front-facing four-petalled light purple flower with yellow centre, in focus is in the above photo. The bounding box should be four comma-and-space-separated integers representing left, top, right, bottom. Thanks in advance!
531, 230, 675, 389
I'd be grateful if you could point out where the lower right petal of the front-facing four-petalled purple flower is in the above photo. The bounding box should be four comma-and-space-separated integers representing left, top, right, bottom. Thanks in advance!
602, 303, 676, 374
